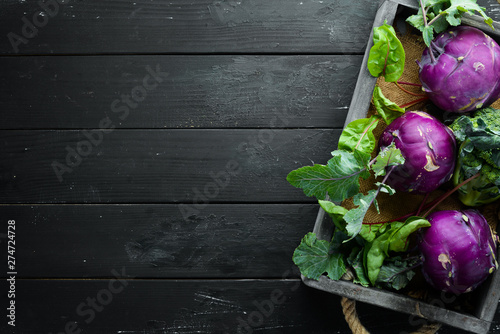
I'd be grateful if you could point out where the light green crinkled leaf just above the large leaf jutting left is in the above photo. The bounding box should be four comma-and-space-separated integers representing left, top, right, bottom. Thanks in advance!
338, 115, 380, 154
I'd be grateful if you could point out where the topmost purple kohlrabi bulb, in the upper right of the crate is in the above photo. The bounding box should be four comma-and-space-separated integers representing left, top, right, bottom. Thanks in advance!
419, 25, 500, 113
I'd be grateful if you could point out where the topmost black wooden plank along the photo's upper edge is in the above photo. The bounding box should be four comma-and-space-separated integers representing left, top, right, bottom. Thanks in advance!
0, 0, 378, 54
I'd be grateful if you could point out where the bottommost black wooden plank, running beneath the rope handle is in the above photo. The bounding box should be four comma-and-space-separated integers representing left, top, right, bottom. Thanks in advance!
0, 280, 480, 334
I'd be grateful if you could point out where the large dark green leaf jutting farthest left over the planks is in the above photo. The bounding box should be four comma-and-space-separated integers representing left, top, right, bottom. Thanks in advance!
287, 150, 370, 202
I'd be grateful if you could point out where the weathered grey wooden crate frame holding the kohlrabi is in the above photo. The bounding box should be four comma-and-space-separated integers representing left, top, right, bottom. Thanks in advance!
302, 0, 500, 334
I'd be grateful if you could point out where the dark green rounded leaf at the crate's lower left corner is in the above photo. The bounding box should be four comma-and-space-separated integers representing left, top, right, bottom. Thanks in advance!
293, 232, 346, 280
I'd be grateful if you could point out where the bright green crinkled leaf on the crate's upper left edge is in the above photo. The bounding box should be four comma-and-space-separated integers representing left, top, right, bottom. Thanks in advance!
367, 23, 405, 82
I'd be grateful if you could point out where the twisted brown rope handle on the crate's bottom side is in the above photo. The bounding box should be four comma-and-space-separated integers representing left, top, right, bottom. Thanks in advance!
340, 270, 442, 334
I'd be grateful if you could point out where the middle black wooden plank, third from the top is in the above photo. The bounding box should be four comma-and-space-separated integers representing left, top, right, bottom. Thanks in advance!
0, 129, 340, 204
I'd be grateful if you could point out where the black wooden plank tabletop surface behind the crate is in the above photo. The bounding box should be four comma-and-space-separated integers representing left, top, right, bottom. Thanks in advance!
0, 0, 500, 334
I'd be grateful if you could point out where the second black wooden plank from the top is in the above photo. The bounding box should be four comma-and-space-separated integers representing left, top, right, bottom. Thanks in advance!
0, 55, 361, 129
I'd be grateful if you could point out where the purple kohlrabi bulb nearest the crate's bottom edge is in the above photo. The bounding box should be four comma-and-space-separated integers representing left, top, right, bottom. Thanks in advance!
418, 209, 498, 295
